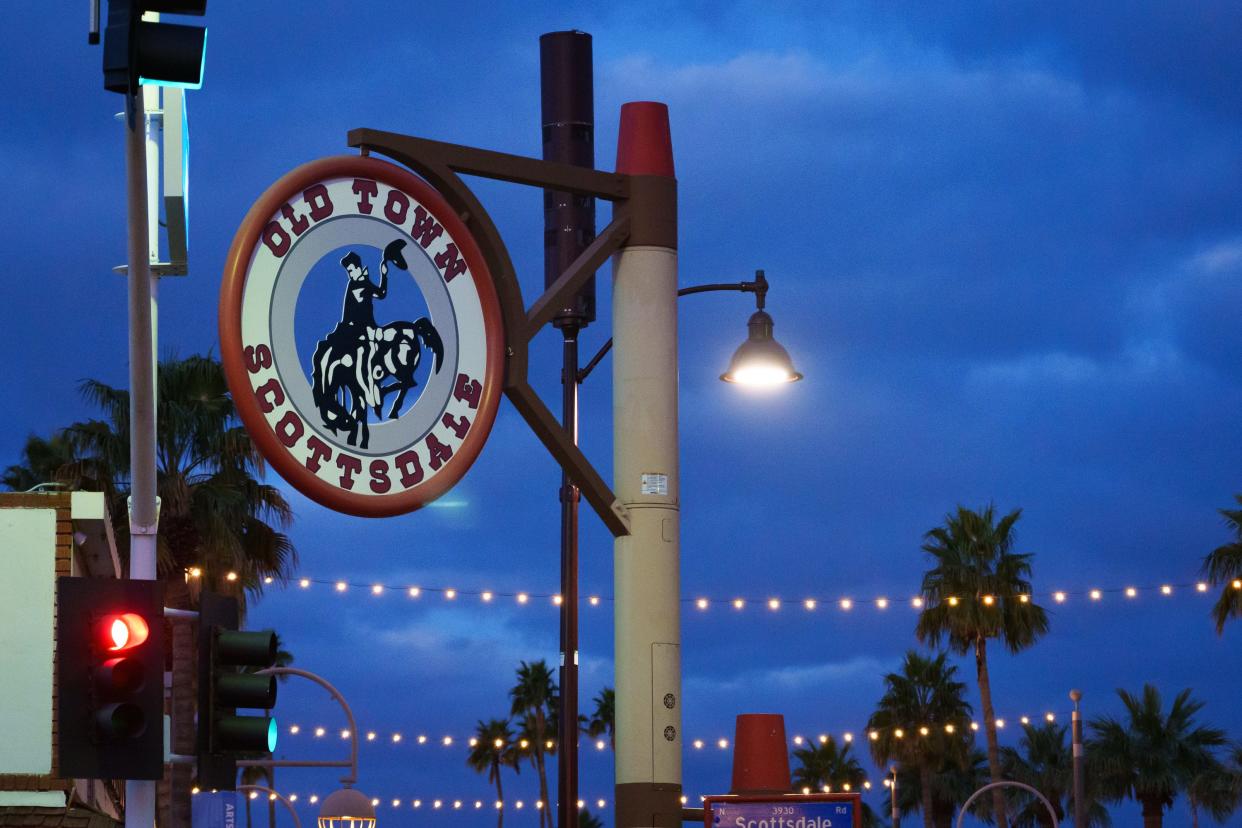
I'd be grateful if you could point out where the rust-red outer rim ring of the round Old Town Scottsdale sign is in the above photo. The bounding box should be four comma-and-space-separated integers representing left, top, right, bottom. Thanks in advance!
220, 155, 505, 518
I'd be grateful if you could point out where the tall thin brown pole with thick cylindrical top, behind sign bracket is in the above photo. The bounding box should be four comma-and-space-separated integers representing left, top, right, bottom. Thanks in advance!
539, 31, 595, 828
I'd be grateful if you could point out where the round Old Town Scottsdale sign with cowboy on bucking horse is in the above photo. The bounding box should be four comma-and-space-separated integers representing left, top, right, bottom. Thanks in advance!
220, 156, 504, 516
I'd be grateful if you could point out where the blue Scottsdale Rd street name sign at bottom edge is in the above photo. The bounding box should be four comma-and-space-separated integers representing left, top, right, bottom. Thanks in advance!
703, 793, 862, 828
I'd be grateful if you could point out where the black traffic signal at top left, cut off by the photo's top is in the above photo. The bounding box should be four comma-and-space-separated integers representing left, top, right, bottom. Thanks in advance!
103, 0, 207, 94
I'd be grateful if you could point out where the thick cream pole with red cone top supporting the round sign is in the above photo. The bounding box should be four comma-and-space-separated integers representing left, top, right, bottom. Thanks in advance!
611, 102, 682, 828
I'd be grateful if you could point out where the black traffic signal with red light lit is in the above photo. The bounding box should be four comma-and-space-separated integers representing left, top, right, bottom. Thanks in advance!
56, 577, 164, 780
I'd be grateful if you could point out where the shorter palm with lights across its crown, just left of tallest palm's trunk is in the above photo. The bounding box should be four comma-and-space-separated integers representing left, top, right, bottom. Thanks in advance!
867, 650, 971, 828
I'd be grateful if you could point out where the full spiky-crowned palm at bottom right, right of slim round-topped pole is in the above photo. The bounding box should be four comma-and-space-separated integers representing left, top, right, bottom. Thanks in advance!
1087, 684, 1225, 828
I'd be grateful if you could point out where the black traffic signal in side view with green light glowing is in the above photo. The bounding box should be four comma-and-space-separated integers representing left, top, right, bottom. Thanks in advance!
199, 591, 277, 791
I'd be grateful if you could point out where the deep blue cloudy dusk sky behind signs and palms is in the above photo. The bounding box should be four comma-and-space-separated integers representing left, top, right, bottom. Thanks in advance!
0, 2, 1242, 826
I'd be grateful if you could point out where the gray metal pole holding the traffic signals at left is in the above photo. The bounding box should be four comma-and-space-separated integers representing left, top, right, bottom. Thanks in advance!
125, 87, 159, 828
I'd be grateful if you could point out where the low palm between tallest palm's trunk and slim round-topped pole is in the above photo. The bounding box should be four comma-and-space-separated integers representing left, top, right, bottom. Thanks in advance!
1001, 722, 1110, 828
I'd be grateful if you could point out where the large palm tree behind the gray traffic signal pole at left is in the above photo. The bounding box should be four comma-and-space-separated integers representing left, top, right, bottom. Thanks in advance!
18, 356, 297, 828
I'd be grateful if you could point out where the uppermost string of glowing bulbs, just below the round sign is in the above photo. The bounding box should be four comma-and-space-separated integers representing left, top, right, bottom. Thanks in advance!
186, 566, 1242, 612
